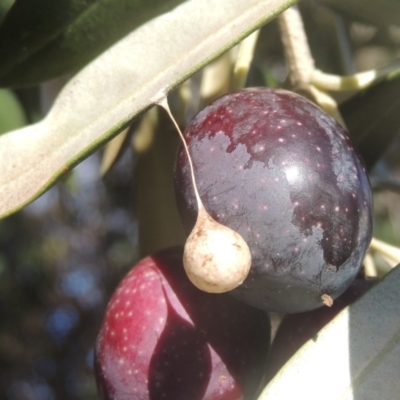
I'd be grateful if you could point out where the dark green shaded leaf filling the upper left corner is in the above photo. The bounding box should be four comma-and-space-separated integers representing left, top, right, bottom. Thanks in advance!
0, 0, 183, 87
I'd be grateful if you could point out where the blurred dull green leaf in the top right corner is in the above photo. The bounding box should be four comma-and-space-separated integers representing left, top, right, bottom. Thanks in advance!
319, 0, 400, 28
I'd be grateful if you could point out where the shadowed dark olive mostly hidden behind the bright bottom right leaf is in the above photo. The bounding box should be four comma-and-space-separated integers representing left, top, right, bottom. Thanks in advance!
267, 278, 378, 381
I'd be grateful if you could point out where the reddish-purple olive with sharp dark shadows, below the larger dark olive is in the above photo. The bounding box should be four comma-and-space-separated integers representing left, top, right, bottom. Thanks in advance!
95, 248, 270, 400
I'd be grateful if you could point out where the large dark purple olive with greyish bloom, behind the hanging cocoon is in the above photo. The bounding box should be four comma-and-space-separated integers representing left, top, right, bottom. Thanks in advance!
175, 88, 372, 313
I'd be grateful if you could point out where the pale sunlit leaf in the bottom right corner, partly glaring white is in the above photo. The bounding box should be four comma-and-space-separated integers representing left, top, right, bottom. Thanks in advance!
258, 266, 400, 400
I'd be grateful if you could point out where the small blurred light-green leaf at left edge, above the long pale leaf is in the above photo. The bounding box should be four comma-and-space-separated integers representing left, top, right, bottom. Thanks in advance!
0, 89, 27, 135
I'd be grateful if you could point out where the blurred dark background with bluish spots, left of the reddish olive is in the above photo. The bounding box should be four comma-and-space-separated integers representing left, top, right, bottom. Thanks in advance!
0, 154, 138, 400
